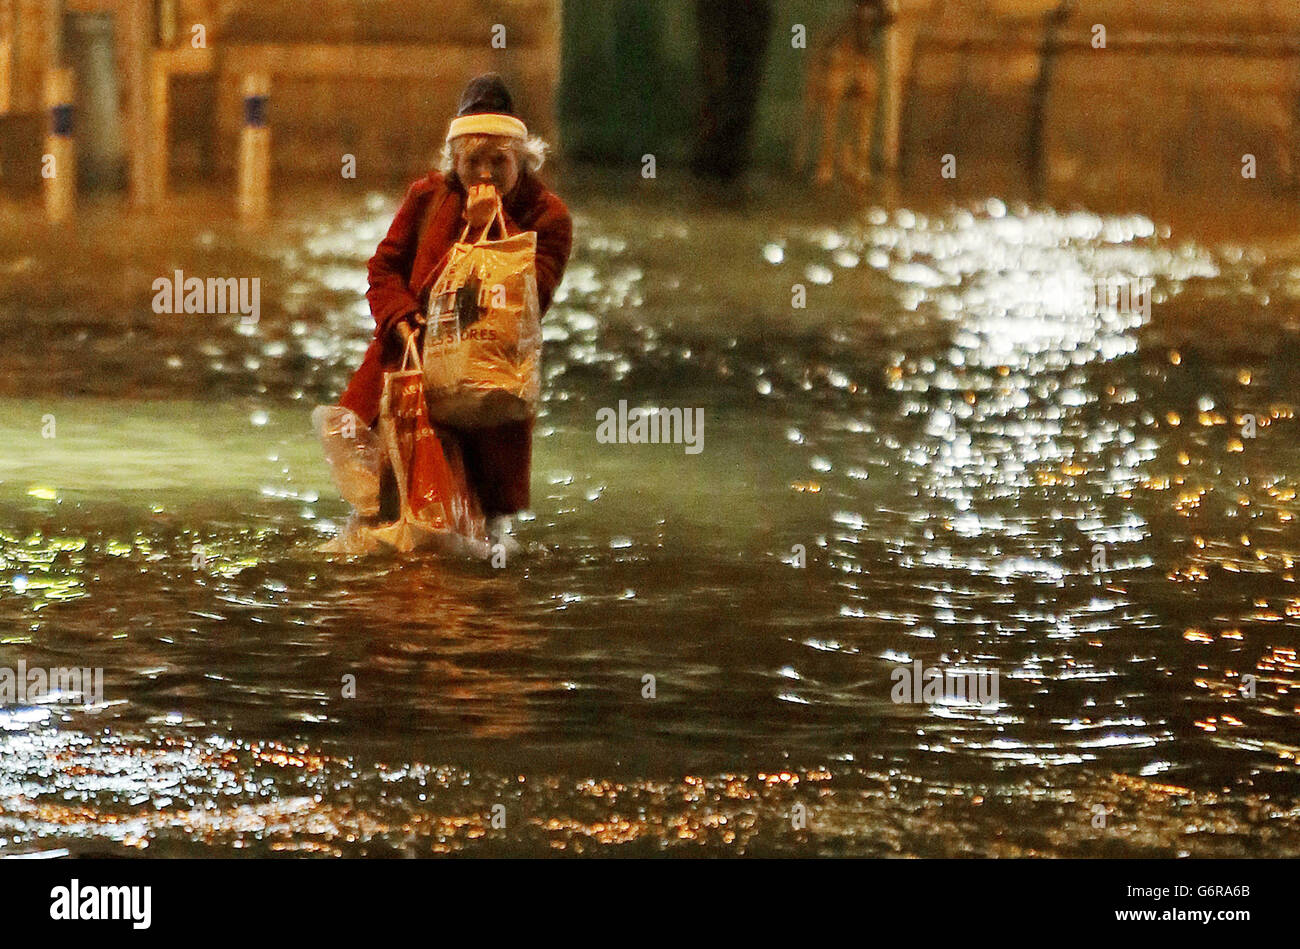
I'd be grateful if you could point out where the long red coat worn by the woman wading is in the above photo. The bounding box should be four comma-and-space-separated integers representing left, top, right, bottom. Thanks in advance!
339, 172, 573, 516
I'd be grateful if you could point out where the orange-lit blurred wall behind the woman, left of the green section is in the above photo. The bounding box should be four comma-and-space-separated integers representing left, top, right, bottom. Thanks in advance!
0, 0, 560, 203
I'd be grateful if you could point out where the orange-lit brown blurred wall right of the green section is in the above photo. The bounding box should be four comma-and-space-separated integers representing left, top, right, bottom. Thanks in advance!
901, 0, 1300, 195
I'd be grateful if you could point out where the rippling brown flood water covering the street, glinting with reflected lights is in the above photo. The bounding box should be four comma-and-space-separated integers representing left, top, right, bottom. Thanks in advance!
0, 174, 1300, 857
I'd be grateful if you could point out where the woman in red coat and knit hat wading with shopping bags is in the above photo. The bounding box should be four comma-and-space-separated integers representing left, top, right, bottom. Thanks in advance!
339, 74, 573, 540
